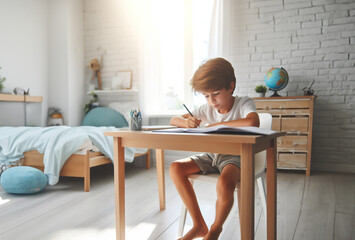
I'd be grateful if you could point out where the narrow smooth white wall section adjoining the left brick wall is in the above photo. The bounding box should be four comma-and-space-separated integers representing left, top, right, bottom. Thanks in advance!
48, 0, 85, 126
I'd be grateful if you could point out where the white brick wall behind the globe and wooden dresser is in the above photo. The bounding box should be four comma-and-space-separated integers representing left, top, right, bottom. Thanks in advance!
230, 0, 355, 172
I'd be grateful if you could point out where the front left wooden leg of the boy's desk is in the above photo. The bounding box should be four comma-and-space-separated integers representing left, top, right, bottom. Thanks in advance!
113, 137, 126, 240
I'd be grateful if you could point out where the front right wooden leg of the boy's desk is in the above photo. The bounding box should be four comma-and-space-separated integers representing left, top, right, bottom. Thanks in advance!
240, 144, 255, 240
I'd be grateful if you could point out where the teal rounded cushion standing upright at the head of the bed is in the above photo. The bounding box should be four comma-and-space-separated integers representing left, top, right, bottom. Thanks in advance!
82, 107, 128, 128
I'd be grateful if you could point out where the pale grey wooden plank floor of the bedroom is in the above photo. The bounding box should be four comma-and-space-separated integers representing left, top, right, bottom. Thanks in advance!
0, 165, 355, 240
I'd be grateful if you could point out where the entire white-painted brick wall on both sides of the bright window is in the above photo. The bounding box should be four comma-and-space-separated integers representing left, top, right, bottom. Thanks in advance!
84, 0, 355, 172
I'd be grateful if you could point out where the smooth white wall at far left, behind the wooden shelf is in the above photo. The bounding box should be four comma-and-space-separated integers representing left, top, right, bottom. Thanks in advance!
0, 0, 48, 126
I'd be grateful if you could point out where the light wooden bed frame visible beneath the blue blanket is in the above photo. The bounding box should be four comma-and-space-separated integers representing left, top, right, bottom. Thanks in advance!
21, 149, 151, 192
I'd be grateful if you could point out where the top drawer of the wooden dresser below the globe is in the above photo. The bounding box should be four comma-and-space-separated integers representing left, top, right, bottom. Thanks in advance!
255, 100, 310, 109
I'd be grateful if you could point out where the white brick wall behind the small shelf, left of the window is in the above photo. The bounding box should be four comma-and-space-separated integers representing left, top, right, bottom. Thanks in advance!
84, 0, 138, 113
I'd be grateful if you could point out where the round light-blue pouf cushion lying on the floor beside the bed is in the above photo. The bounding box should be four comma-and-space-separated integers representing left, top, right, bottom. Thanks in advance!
0, 166, 47, 194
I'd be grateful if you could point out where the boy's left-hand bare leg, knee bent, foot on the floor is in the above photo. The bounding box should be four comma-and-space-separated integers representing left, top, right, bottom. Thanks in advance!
169, 158, 208, 239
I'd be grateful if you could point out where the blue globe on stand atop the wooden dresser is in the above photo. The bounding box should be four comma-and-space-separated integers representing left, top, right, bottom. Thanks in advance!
265, 68, 288, 97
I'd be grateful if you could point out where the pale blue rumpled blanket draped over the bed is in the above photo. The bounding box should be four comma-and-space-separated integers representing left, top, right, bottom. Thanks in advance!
0, 126, 146, 185
